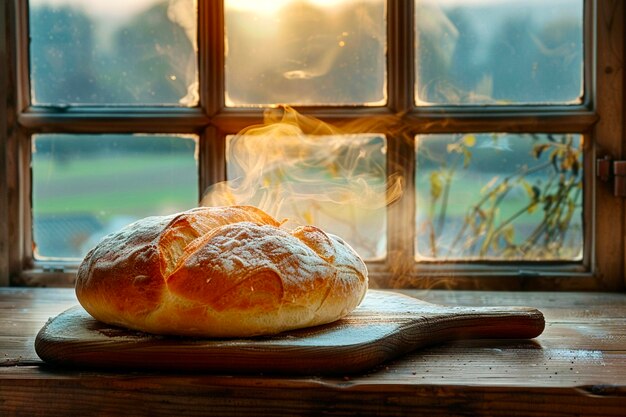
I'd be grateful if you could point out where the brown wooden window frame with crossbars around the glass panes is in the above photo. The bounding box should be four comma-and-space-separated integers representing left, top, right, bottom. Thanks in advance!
0, 0, 626, 291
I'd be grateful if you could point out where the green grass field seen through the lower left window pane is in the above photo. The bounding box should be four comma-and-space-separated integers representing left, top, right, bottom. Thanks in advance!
33, 154, 198, 219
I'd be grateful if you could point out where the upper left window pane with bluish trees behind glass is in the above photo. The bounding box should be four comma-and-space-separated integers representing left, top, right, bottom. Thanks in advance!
30, 0, 198, 106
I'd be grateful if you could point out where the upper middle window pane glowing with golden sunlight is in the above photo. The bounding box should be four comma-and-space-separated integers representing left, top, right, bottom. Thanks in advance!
225, 0, 386, 107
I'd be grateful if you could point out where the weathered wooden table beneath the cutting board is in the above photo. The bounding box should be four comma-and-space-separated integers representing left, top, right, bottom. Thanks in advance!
0, 288, 626, 417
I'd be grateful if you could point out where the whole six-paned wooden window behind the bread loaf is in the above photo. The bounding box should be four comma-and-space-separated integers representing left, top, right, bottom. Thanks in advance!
0, 0, 624, 289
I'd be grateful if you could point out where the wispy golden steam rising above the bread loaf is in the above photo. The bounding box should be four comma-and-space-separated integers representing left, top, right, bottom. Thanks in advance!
201, 107, 403, 224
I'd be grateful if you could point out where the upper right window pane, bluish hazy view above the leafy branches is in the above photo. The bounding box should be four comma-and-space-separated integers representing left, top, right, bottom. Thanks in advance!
415, 0, 583, 105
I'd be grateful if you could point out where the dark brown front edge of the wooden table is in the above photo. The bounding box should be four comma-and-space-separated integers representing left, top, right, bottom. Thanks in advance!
0, 373, 624, 417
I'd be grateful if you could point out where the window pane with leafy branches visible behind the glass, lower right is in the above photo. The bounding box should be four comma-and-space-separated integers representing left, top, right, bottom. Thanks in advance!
416, 133, 583, 261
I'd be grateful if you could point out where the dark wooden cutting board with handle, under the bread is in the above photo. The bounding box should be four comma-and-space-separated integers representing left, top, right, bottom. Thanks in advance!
35, 290, 544, 375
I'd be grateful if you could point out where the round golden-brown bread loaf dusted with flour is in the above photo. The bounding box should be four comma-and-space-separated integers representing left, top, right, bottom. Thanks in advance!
76, 206, 367, 337
